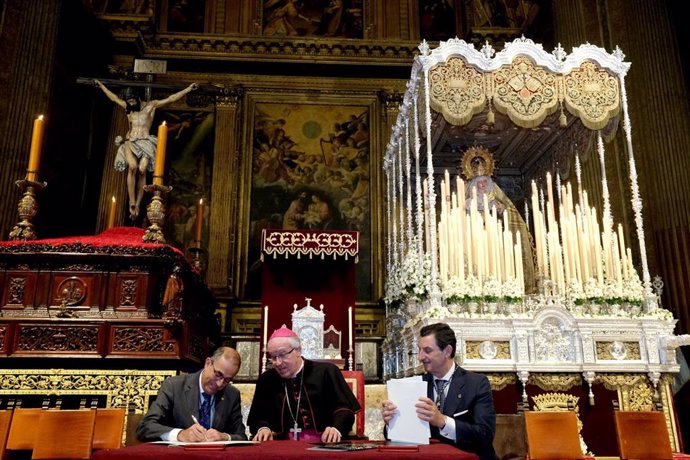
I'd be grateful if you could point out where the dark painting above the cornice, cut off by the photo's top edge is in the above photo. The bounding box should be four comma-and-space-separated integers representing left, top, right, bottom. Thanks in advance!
261, 0, 365, 38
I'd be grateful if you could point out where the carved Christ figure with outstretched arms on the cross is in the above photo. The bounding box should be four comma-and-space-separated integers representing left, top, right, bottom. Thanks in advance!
93, 80, 198, 220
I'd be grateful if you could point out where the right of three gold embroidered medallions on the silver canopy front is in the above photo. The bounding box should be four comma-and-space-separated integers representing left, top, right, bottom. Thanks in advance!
563, 62, 621, 130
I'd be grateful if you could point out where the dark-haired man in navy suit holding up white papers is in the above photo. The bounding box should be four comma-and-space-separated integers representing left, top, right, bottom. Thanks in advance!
383, 323, 496, 460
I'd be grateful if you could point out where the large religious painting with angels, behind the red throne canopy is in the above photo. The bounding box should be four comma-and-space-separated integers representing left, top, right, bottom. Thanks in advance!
243, 94, 379, 301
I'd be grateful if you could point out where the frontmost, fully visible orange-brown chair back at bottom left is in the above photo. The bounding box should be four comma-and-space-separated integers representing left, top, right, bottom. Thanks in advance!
31, 409, 96, 460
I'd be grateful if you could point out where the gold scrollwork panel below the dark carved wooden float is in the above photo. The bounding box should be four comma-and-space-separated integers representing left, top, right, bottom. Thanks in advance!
0, 369, 176, 414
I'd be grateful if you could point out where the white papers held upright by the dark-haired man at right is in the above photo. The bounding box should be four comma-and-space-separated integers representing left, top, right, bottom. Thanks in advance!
386, 376, 431, 444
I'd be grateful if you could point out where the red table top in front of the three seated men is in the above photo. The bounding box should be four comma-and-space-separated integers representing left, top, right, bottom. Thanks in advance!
91, 441, 478, 460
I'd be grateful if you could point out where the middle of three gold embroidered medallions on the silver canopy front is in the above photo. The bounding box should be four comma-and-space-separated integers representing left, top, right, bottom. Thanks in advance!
492, 56, 559, 128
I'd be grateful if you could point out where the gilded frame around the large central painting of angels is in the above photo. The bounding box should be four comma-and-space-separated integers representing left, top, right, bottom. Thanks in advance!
236, 88, 383, 302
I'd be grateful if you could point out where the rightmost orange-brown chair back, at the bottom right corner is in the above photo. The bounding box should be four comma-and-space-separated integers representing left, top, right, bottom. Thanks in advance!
614, 411, 673, 460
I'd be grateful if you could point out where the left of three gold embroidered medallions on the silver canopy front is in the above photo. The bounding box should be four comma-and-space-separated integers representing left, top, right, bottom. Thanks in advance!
429, 57, 486, 126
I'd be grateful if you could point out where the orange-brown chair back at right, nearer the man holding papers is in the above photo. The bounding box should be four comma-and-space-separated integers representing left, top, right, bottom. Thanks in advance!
525, 411, 584, 460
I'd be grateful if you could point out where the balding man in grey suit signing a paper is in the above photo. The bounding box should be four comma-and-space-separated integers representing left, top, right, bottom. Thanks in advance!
137, 347, 247, 442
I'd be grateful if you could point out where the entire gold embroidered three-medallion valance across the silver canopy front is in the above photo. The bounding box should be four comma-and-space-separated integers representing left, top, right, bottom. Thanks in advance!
429, 55, 621, 130
